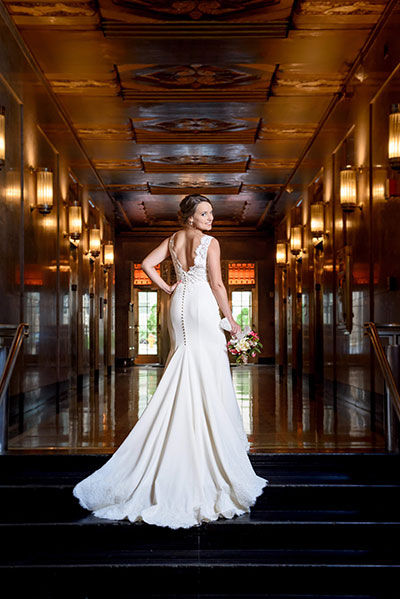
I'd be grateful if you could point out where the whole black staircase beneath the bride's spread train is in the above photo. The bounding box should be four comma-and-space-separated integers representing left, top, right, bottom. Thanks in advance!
0, 453, 400, 599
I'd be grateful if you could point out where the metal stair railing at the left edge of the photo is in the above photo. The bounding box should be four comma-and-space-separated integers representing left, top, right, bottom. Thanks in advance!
0, 322, 29, 453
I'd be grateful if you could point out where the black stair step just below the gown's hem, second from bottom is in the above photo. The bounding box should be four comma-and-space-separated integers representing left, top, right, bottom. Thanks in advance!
0, 516, 400, 562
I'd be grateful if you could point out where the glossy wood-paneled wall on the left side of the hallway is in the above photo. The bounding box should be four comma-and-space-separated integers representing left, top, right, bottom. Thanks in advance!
0, 12, 115, 415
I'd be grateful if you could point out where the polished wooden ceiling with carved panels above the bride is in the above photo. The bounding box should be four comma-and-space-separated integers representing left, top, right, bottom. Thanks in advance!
5, 0, 386, 231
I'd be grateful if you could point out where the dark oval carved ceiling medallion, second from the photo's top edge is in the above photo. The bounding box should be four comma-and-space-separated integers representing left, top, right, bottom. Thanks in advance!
132, 64, 260, 89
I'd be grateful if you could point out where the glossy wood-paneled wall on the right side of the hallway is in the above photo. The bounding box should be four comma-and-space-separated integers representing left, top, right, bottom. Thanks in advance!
275, 14, 400, 407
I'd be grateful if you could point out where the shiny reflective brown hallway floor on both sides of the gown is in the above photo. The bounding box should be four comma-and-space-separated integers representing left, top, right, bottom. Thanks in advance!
9, 364, 385, 453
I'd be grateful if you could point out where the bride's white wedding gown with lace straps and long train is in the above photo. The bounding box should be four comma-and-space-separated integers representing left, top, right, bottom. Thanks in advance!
73, 233, 269, 529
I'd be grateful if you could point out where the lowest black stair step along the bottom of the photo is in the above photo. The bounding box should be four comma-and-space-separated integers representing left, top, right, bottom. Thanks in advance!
0, 562, 400, 599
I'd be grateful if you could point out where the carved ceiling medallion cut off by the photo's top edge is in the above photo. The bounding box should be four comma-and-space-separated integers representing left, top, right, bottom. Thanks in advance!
113, 0, 277, 21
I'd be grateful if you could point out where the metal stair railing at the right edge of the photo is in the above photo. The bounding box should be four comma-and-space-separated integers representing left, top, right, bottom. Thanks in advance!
364, 322, 400, 451
